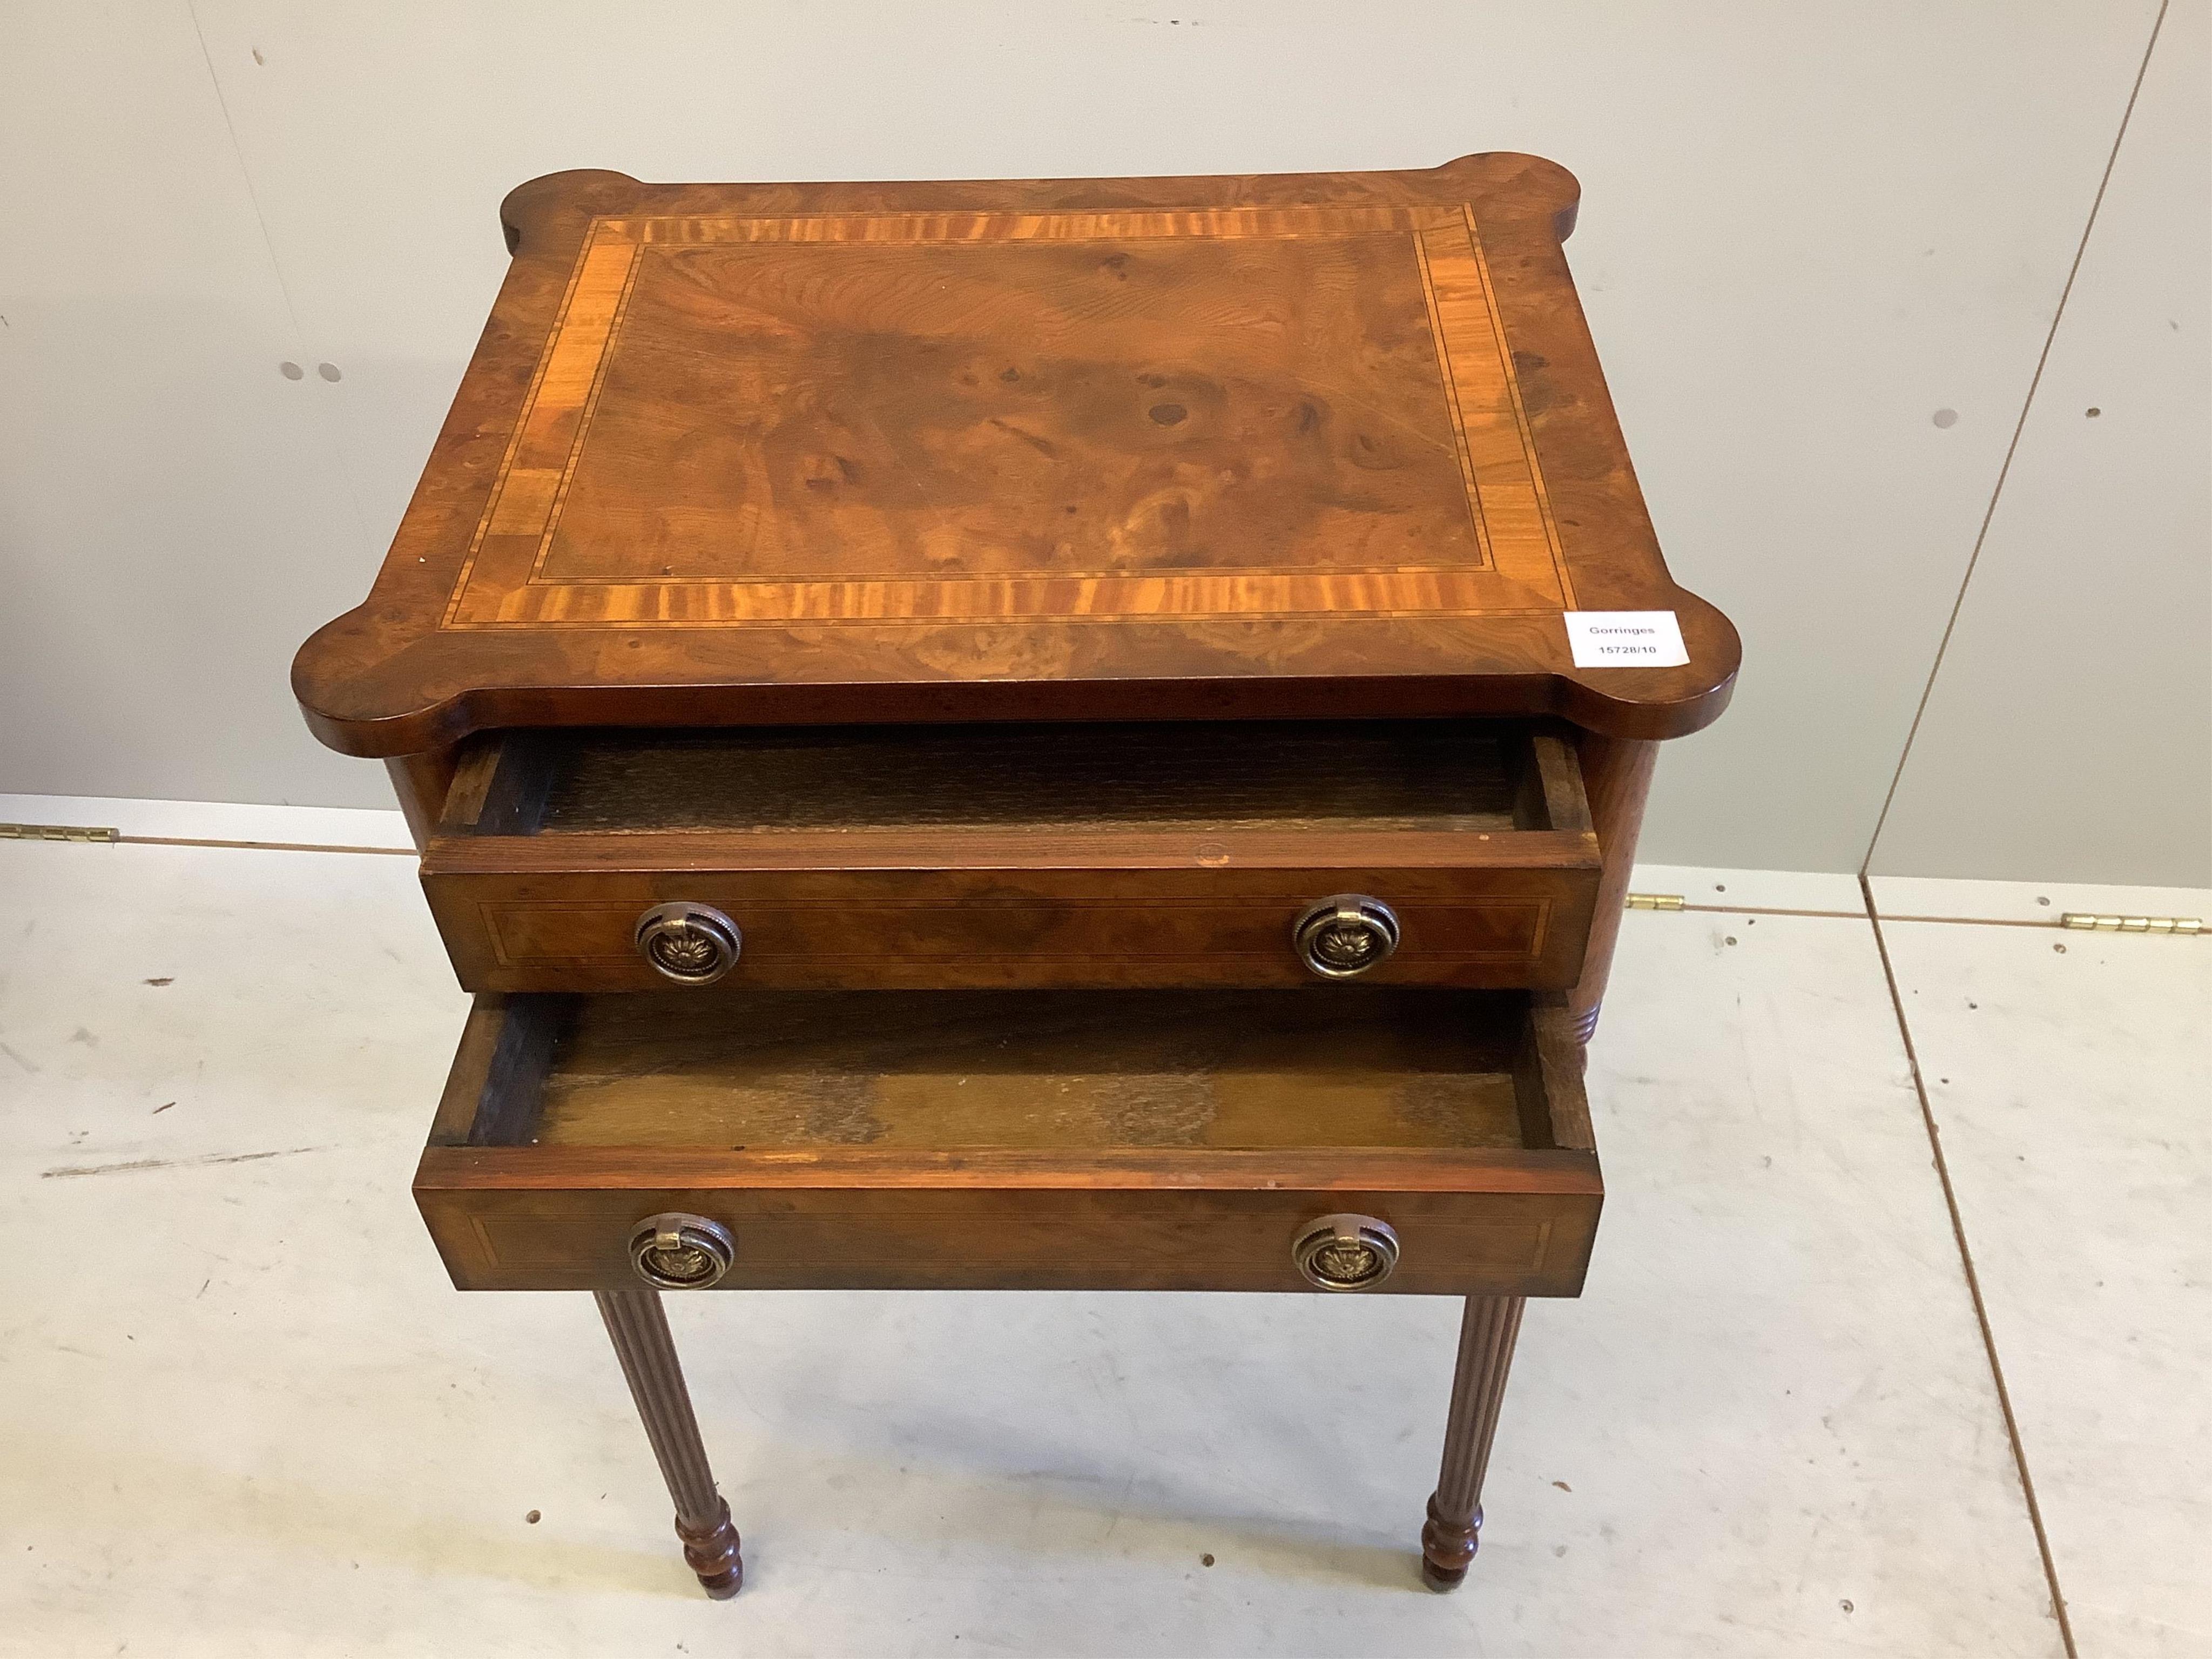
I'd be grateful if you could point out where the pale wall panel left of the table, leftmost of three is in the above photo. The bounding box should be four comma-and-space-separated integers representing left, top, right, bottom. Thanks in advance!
0, 0, 383, 805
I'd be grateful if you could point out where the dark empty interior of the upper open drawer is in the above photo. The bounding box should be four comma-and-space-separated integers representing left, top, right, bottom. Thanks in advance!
440, 719, 1588, 836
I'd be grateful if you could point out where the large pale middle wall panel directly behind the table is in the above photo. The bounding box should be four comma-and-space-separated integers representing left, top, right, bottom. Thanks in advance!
0, 0, 2155, 885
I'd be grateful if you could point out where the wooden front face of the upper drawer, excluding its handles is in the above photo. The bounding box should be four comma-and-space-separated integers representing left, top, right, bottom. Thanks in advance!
422, 862, 1597, 991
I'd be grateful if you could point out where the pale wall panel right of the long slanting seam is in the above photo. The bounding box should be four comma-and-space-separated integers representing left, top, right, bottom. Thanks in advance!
1871, 0, 2212, 887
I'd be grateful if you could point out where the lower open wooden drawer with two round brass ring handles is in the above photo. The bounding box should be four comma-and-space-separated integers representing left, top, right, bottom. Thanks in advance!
416, 987, 1604, 1296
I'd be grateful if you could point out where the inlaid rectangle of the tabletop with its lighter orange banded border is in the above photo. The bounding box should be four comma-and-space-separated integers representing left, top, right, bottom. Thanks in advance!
431, 208, 1573, 628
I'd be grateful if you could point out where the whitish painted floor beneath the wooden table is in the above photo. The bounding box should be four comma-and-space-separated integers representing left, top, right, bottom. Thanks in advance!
0, 822, 2212, 1659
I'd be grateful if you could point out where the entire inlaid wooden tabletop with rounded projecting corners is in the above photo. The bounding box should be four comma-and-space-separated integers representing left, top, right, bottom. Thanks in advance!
294, 157, 1736, 754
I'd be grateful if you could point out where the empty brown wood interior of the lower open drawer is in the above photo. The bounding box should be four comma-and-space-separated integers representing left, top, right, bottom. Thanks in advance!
449, 987, 1557, 1152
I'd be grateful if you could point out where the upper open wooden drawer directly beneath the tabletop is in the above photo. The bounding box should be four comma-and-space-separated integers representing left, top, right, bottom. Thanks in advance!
422, 721, 1599, 991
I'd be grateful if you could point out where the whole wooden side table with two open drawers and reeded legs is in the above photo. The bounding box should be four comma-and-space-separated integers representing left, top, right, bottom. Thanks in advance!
292, 155, 1738, 1595
